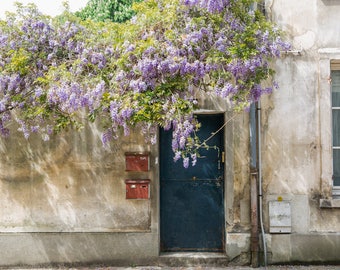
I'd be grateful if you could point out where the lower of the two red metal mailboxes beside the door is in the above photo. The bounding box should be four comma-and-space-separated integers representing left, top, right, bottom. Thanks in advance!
125, 179, 150, 199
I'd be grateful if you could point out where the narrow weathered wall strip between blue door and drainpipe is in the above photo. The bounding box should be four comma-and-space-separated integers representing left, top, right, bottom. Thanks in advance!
225, 112, 250, 265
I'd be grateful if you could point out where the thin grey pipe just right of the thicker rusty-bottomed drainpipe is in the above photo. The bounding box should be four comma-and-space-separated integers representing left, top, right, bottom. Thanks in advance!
257, 100, 267, 267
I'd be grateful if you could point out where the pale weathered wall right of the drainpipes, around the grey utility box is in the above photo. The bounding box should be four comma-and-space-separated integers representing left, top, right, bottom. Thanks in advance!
262, 0, 340, 262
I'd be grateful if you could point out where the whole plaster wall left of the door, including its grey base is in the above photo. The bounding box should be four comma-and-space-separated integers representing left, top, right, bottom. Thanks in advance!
0, 122, 159, 266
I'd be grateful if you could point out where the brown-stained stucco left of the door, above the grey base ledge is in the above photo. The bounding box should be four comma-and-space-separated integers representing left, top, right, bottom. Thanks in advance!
0, 123, 155, 232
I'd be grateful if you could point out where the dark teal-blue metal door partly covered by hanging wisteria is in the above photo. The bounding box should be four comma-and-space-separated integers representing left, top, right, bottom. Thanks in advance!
160, 114, 225, 252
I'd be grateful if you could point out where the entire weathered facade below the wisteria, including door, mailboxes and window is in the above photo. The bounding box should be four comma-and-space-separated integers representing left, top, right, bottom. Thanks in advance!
0, 0, 340, 266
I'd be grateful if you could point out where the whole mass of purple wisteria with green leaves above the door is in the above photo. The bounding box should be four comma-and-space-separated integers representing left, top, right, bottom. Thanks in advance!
0, 0, 288, 167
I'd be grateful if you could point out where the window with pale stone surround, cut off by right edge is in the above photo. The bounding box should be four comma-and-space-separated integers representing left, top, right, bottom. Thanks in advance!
316, 51, 340, 208
